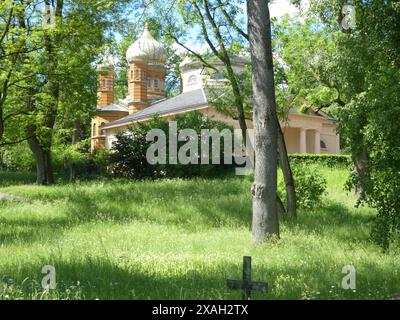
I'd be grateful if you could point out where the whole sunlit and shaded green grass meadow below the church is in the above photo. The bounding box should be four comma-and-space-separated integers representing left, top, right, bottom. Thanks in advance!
0, 167, 400, 299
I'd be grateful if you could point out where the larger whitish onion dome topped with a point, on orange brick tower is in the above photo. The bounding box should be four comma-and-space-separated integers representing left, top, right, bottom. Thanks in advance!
126, 23, 167, 65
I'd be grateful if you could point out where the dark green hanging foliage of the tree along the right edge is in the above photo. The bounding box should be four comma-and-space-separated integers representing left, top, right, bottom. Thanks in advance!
302, 0, 400, 249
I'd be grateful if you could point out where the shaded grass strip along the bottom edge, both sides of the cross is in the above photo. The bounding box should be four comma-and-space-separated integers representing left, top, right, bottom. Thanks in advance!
0, 252, 399, 300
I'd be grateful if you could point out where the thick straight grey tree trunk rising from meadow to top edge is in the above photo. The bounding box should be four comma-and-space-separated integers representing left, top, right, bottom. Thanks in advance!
247, 0, 279, 243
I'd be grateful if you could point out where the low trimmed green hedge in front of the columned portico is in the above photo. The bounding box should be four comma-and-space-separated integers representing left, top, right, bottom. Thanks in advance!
289, 154, 352, 167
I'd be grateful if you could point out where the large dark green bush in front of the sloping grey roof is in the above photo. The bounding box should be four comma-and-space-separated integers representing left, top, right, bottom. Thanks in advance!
108, 112, 233, 179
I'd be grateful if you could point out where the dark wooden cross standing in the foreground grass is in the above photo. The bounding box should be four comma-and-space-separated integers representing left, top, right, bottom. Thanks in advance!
227, 257, 268, 300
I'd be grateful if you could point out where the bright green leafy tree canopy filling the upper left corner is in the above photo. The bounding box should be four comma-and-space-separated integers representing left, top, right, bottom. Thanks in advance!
0, 0, 133, 183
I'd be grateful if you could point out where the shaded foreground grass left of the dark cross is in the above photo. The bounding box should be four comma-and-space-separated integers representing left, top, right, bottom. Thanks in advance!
0, 257, 240, 300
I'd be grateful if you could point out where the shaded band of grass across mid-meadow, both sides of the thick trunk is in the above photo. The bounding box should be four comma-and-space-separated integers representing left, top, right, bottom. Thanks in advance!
0, 179, 373, 243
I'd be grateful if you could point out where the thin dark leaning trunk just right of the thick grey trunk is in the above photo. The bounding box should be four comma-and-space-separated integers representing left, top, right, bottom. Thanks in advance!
277, 119, 297, 219
